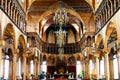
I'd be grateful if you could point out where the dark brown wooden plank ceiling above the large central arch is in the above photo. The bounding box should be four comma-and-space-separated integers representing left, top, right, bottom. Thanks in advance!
28, 0, 92, 15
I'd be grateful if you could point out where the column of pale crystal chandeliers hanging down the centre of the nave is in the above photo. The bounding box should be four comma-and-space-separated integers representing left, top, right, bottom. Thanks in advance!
53, 1, 68, 60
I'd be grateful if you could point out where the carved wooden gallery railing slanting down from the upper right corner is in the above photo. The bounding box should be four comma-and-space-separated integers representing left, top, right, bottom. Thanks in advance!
95, 0, 120, 33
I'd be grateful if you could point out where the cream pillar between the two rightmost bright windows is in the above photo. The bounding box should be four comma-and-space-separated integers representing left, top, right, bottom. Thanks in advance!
104, 53, 110, 80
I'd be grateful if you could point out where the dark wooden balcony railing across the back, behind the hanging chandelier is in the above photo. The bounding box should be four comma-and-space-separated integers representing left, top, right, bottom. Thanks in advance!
42, 42, 81, 54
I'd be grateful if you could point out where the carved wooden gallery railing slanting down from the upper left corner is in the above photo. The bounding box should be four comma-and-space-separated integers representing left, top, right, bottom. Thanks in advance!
0, 0, 26, 33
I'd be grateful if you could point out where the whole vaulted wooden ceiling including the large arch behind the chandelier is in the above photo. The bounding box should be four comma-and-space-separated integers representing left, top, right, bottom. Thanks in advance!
28, 0, 94, 42
